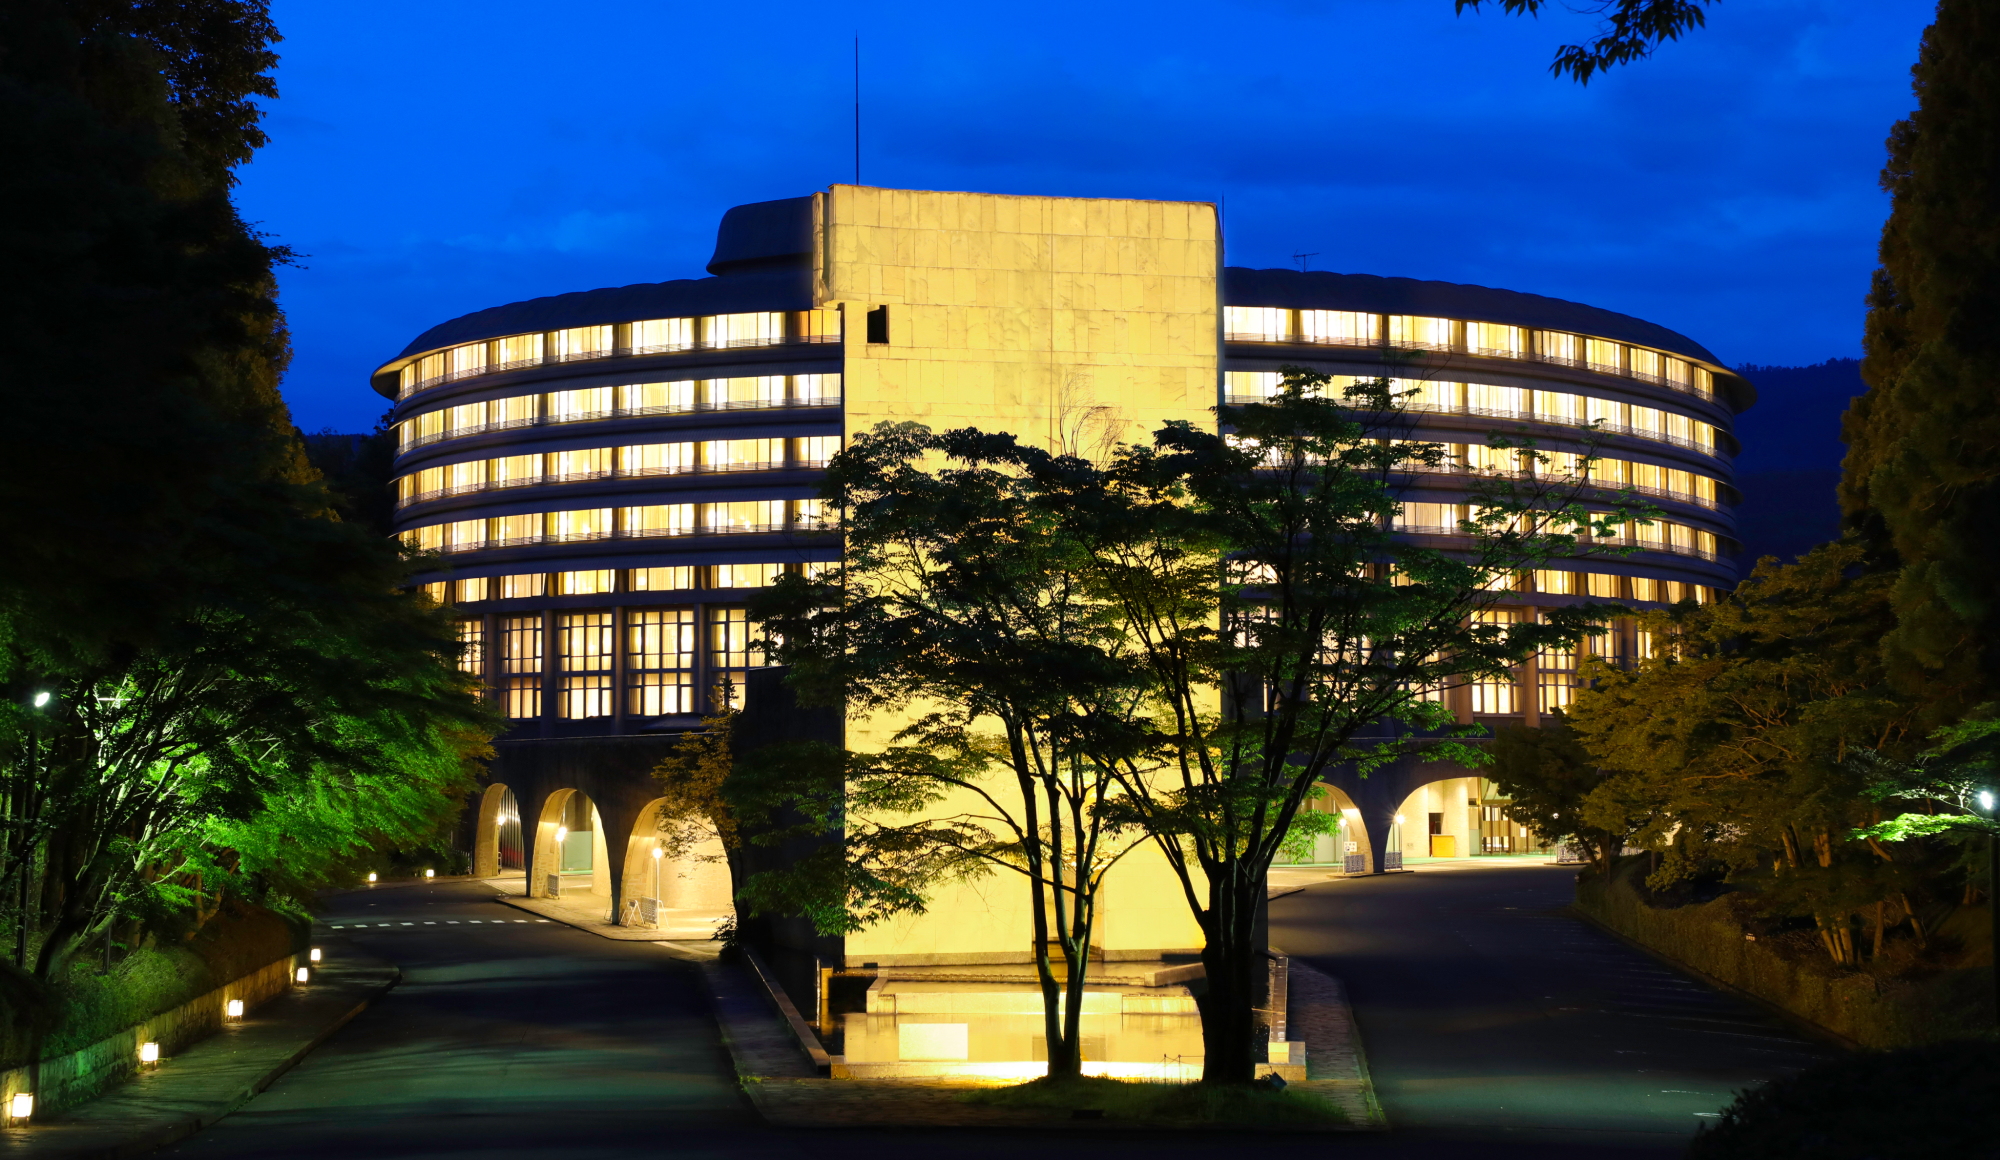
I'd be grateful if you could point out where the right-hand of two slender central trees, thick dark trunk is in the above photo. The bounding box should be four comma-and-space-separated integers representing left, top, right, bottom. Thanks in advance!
1032, 366, 1640, 1082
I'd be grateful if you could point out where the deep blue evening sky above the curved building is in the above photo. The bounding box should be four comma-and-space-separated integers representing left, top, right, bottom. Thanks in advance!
240, 0, 1930, 430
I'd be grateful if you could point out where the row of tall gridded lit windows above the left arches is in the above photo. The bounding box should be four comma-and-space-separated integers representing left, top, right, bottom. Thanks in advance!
458, 608, 764, 720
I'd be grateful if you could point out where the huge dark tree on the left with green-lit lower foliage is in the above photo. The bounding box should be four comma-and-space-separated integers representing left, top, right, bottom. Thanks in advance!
0, 0, 486, 1008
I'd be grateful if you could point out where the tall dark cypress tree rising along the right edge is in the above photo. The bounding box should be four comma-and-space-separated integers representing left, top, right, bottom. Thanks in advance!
1840, 0, 2000, 708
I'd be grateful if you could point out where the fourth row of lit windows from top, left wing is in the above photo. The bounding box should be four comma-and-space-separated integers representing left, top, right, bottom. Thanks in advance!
402, 500, 832, 552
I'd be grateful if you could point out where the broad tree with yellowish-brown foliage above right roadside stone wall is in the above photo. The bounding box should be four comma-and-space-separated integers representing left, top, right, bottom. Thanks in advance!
1568, 544, 1922, 966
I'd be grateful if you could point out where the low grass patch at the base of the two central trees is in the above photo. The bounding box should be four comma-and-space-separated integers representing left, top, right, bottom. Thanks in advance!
960, 1076, 1348, 1128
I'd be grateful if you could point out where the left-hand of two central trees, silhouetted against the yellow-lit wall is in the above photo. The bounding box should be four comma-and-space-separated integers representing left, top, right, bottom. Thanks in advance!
752, 424, 1146, 1076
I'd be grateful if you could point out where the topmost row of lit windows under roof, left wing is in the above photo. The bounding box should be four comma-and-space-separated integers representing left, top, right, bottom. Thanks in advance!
400, 310, 840, 394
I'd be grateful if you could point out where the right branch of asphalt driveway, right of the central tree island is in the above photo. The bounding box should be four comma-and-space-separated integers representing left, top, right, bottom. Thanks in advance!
1270, 864, 1834, 1156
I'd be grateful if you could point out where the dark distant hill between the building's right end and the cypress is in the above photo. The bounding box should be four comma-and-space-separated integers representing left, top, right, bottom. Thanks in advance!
1736, 358, 1868, 574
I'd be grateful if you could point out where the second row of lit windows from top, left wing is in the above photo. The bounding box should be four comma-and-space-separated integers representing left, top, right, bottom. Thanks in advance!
396, 374, 840, 450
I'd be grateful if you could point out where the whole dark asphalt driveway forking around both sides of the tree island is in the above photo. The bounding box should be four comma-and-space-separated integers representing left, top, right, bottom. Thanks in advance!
164, 870, 1812, 1160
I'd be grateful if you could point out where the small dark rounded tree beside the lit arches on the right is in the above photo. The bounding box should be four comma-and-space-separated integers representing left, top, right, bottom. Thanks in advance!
1486, 712, 1648, 878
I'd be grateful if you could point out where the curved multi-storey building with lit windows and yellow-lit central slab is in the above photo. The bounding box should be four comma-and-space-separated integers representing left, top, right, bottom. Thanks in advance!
374, 186, 1754, 960
